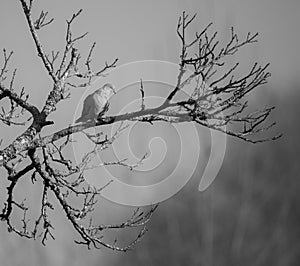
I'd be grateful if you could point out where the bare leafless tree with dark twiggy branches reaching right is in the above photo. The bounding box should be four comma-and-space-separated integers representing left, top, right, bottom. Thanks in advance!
0, 0, 280, 251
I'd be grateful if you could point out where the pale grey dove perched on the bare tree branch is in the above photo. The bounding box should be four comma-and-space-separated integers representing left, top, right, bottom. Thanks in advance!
75, 83, 116, 123
